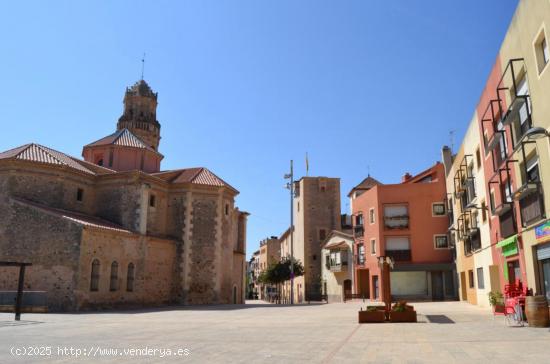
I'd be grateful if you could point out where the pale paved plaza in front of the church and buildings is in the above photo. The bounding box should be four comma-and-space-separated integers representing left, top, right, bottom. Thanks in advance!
0, 301, 550, 363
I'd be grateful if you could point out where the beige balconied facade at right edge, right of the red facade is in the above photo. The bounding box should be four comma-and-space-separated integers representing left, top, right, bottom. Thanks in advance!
499, 0, 550, 299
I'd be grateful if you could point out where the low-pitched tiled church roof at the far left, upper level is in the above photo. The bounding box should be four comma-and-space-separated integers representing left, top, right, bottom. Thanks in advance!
0, 143, 95, 174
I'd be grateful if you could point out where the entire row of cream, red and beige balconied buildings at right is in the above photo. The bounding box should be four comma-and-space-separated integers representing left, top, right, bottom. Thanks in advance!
444, 0, 550, 305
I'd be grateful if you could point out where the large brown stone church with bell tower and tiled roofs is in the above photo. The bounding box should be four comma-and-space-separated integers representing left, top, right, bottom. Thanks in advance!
0, 80, 248, 311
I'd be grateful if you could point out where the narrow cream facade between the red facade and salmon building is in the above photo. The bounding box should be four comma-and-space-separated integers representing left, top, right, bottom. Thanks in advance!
442, 115, 500, 307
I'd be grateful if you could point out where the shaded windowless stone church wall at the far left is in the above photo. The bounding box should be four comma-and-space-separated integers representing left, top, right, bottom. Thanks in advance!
0, 199, 82, 311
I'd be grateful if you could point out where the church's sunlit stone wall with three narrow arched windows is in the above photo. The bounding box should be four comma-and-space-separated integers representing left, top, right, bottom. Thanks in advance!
75, 229, 176, 309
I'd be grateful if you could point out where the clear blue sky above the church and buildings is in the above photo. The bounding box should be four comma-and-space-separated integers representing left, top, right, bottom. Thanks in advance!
0, 0, 517, 254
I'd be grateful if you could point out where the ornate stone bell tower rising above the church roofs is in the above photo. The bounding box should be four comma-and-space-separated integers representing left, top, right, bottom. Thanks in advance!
117, 80, 160, 150
